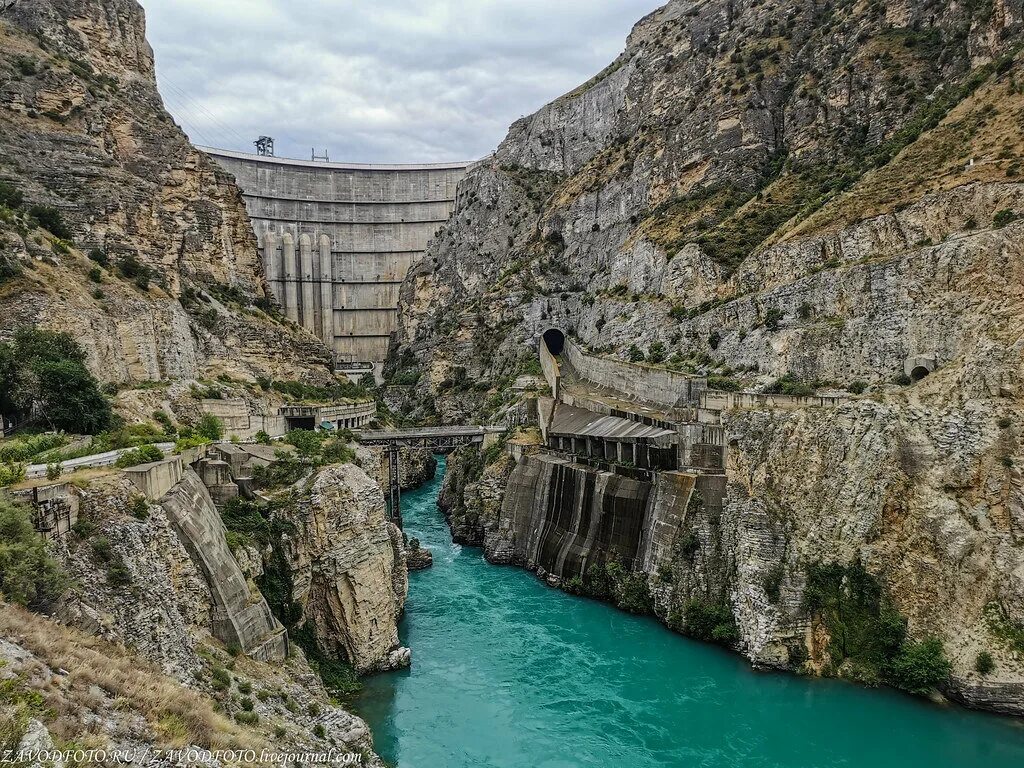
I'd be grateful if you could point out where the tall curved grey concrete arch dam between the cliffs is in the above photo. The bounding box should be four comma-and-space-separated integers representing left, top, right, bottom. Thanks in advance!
202, 147, 469, 372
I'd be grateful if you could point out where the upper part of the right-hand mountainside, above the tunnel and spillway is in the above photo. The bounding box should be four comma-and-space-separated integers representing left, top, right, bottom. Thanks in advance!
391, 0, 1021, 420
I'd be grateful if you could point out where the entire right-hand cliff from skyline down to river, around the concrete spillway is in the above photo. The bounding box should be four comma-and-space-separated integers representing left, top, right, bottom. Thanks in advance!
391, 0, 1024, 714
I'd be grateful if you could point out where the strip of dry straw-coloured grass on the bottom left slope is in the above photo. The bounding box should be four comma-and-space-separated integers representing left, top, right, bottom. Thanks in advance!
0, 603, 266, 750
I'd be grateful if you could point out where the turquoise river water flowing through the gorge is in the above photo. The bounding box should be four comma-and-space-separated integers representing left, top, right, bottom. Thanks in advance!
357, 461, 1024, 768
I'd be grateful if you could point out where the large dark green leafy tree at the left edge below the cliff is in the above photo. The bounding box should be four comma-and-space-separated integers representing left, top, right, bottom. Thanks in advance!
0, 328, 114, 434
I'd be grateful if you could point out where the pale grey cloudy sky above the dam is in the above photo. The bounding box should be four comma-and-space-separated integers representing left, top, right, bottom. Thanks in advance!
141, 0, 664, 163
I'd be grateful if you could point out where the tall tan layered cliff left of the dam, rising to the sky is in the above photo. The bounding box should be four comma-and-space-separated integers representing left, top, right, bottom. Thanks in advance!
0, 0, 329, 383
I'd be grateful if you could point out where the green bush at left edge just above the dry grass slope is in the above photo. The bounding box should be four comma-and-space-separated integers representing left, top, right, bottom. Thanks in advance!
0, 499, 68, 611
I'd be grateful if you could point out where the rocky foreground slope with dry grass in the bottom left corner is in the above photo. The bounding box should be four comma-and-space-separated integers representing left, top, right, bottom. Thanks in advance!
40, 472, 390, 765
